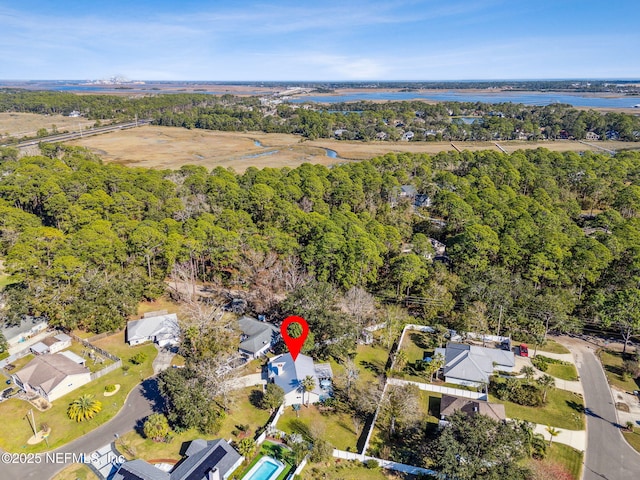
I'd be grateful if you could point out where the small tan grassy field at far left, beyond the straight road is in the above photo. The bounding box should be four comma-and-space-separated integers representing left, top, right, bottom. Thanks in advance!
0, 112, 95, 138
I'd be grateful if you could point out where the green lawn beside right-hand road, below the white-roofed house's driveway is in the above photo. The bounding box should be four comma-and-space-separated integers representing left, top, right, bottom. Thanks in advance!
489, 388, 584, 430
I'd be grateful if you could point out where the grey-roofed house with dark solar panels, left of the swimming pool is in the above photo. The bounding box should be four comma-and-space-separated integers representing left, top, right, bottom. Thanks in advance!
112, 439, 244, 480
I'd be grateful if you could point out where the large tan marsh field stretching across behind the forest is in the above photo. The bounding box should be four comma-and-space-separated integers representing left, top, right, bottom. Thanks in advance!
71, 126, 633, 172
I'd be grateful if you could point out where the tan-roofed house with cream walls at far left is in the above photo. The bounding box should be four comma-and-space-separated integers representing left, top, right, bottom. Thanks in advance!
11, 353, 91, 402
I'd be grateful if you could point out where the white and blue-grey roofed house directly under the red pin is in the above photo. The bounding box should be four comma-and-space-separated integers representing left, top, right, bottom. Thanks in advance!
268, 353, 333, 406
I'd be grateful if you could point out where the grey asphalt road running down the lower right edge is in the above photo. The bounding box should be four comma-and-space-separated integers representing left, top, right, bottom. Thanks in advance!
574, 346, 640, 480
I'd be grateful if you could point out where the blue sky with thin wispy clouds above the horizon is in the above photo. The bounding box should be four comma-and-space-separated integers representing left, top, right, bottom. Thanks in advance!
0, 0, 640, 81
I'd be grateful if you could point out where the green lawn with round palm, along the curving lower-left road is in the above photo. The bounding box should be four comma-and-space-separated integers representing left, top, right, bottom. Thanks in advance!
0, 333, 157, 453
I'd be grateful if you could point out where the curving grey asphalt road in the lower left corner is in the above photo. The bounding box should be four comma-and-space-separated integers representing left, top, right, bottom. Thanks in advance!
0, 378, 161, 480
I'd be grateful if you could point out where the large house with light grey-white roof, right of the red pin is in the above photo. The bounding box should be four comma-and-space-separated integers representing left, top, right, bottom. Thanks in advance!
435, 342, 516, 387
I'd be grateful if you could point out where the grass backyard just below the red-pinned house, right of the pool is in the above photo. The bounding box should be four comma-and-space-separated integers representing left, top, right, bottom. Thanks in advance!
277, 405, 360, 452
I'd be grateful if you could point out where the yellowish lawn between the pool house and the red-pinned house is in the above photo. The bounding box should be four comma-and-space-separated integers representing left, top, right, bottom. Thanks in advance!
119, 387, 270, 462
